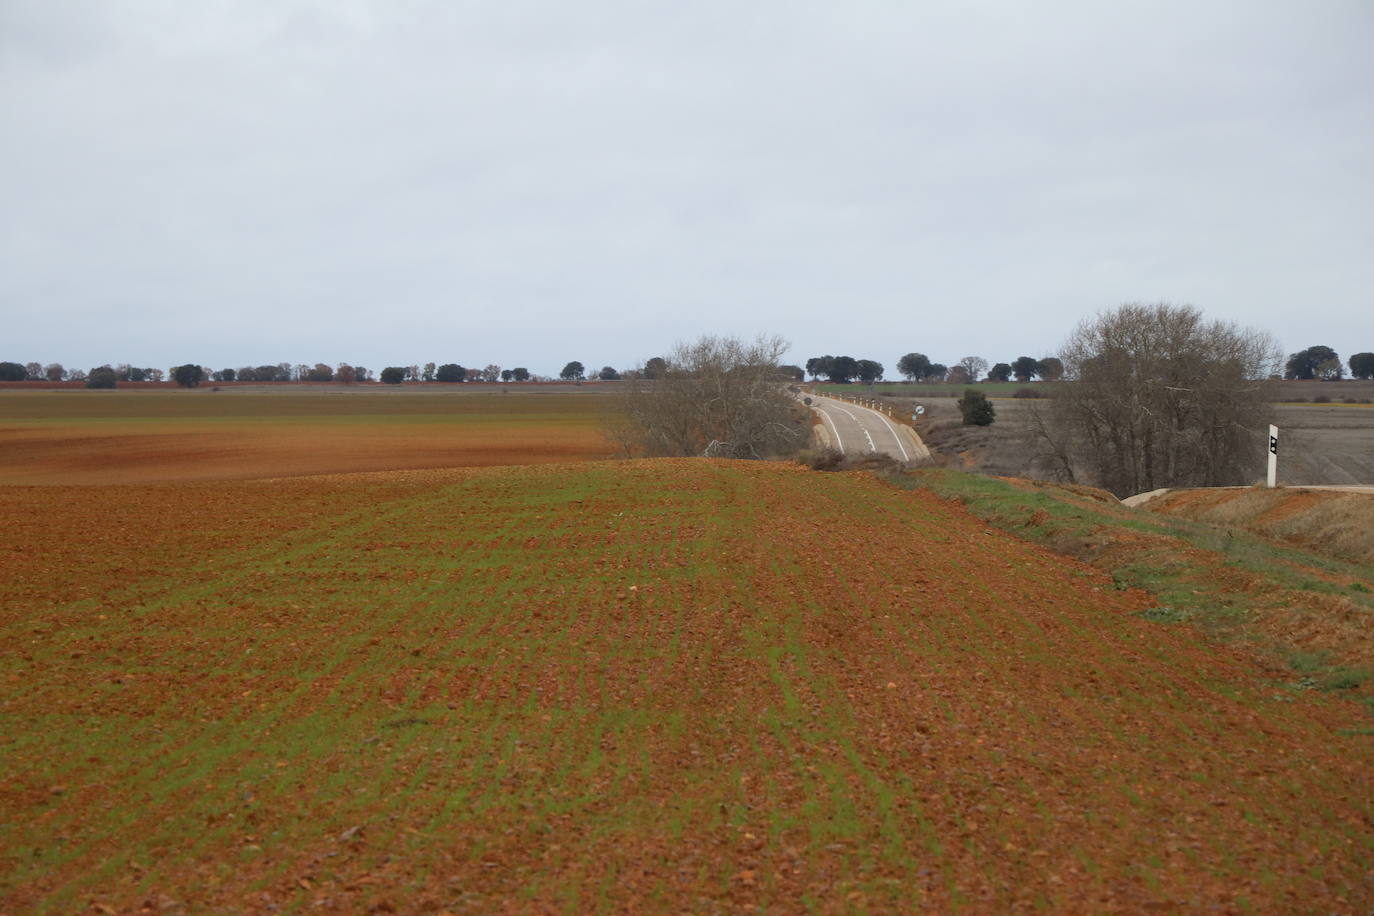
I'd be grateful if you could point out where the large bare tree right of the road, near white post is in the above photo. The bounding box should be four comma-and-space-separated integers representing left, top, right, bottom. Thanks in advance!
1044, 304, 1282, 496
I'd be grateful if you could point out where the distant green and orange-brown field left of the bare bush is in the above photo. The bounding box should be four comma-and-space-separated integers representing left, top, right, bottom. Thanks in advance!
0, 386, 614, 485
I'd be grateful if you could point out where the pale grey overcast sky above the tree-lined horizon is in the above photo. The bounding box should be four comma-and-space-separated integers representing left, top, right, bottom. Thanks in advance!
0, 0, 1374, 378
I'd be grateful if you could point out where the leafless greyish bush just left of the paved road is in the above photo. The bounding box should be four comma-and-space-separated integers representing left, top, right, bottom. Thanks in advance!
613, 336, 809, 459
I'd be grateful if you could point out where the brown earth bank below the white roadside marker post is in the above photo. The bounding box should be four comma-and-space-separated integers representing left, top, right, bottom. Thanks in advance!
1143, 488, 1374, 563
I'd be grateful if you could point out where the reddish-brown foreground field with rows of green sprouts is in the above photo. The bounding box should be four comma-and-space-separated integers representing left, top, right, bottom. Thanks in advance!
0, 460, 1374, 912
